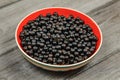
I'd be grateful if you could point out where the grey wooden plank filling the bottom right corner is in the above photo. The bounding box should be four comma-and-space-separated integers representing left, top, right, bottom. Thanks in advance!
70, 50, 120, 80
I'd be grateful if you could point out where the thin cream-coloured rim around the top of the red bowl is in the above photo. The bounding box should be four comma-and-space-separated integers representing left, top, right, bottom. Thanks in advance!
15, 7, 103, 68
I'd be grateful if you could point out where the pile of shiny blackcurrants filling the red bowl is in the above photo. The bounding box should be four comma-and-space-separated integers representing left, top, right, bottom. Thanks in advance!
19, 12, 97, 65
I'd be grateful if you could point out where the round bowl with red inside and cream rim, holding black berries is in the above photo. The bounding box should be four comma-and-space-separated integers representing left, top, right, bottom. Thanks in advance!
15, 7, 102, 71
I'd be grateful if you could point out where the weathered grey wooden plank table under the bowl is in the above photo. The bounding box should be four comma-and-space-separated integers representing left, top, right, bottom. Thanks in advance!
0, 0, 120, 80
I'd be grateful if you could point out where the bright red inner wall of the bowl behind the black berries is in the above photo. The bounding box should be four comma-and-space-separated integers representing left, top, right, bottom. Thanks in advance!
17, 8, 102, 57
